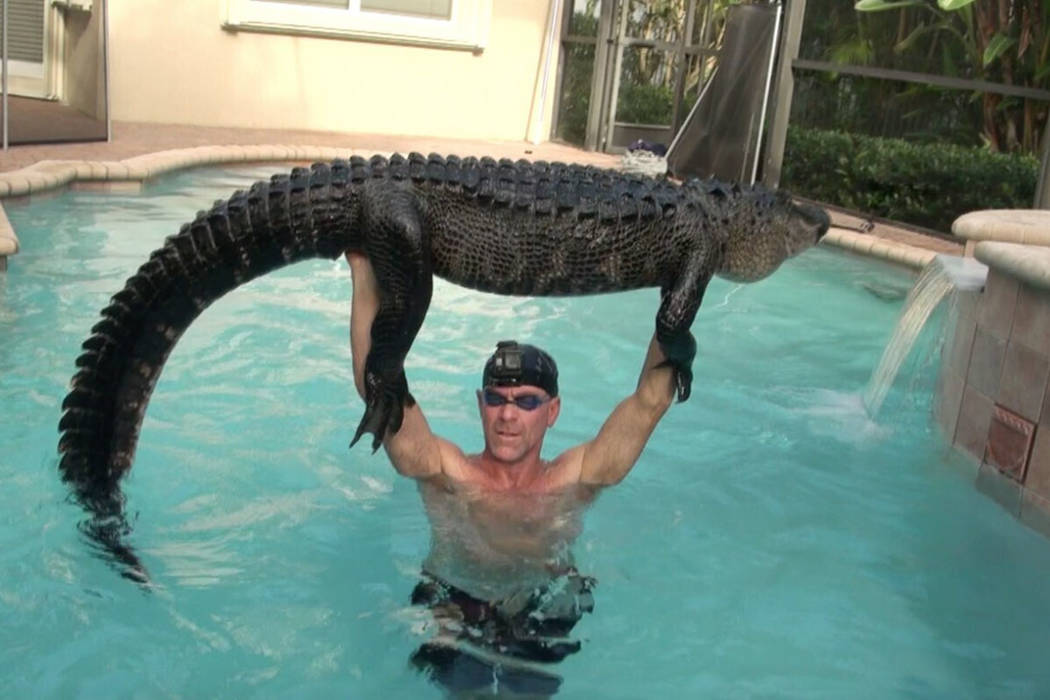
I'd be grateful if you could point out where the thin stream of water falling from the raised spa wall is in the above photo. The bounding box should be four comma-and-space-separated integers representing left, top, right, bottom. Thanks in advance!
864, 255, 988, 418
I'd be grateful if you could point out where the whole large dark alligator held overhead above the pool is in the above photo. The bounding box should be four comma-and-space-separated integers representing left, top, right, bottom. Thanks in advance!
59, 153, 828, 575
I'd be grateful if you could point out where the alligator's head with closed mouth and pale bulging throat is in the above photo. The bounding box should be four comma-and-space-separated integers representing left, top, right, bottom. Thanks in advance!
717, 187, 831, 282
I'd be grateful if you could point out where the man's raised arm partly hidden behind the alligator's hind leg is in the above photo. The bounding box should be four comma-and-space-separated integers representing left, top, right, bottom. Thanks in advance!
347, 253, 447, 479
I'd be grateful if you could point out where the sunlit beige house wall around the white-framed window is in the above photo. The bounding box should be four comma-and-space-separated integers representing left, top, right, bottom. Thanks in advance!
109, 0, 557, 140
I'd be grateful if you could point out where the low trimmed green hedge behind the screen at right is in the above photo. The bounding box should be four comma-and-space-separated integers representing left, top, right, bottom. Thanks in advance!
782, 126, 1040, 232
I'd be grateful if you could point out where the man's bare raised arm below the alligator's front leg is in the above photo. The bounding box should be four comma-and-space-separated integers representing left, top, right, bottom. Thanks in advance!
578, 335, 674, 486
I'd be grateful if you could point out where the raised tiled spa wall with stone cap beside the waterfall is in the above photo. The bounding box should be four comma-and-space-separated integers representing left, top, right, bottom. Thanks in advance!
933, 210, 1050, 537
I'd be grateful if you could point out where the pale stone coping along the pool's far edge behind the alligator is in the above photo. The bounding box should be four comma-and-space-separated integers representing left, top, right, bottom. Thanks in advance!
0, 144, 937, 271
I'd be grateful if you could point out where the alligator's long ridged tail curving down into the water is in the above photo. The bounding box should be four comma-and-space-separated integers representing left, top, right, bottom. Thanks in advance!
59, 158, 369, 579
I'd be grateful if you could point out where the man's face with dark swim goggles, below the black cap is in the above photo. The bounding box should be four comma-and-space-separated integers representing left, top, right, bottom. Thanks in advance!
478, 384, 562, 463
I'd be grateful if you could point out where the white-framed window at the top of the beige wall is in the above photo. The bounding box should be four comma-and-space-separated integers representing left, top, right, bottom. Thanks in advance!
224, 0, 492, 51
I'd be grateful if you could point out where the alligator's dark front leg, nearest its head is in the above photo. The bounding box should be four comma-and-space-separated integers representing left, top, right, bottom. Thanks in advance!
656, 255, 714, 401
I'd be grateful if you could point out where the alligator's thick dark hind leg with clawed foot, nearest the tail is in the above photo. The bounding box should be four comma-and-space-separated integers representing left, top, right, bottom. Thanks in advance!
350, 183, 434, 451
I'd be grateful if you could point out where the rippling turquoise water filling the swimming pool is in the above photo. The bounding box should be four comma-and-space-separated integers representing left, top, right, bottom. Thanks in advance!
0, 167, 1050, 698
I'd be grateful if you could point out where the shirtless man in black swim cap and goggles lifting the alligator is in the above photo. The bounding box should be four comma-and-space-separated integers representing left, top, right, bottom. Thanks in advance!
347, 253, 674, 694
